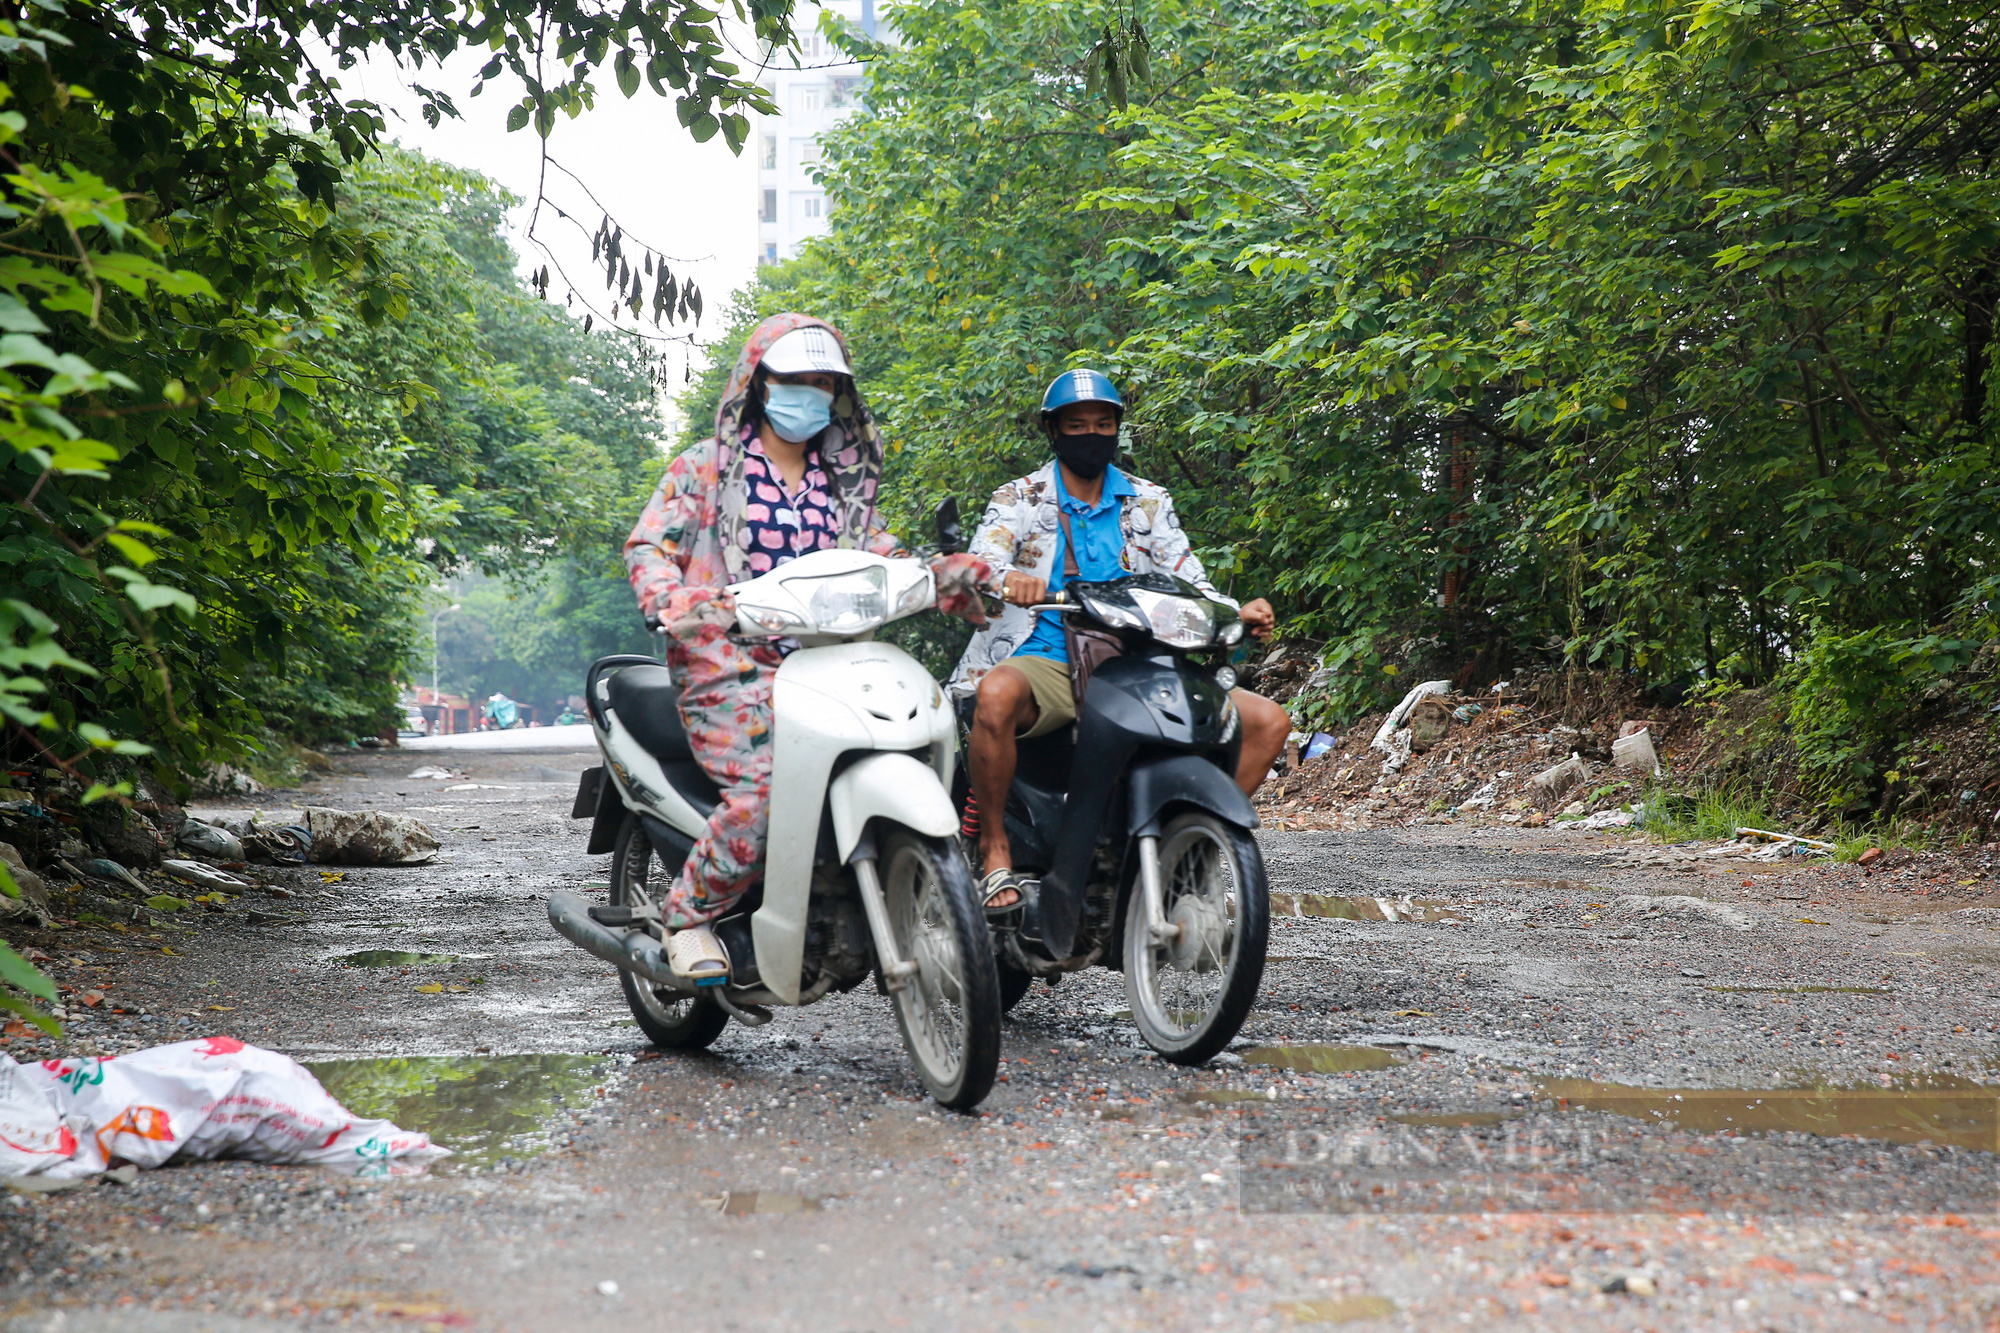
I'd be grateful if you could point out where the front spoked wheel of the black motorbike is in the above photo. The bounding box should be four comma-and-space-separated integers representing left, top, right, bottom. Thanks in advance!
1124, 811, 1270, 1065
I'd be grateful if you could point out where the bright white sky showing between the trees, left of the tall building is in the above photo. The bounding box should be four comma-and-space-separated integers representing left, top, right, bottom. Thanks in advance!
338, 28, 758, 378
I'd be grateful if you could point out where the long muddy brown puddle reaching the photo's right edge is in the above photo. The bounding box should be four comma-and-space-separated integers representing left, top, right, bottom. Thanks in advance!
1538, 1075, 2000, 1153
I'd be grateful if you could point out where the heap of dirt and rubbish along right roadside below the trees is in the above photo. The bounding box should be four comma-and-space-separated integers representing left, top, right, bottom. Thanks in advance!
1258, 681, 1666, 829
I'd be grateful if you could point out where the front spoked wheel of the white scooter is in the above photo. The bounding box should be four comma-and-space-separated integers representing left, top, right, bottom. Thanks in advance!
880, 829, 1000, 1111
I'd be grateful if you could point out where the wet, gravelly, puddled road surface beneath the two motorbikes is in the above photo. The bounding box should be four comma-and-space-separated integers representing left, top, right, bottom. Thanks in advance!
0, 753, 2000, 1333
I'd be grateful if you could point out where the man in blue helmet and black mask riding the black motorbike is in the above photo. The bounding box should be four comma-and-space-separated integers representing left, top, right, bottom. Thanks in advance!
950, 370, 1292, 913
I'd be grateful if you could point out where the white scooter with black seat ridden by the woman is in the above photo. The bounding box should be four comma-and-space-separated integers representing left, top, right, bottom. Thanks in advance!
548, 528, 1000, 1109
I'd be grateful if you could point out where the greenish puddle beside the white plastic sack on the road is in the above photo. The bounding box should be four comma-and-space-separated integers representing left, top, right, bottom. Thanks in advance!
306, 1055, 618, 1175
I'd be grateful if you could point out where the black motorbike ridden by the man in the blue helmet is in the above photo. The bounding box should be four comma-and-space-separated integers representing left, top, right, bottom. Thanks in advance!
952, 574, 1270, 1065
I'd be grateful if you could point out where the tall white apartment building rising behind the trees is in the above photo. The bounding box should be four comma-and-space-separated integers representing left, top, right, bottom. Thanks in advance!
750, 0, 876, 264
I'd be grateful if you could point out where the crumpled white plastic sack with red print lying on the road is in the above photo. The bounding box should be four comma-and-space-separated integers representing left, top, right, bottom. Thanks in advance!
0, 1037, 448, 1179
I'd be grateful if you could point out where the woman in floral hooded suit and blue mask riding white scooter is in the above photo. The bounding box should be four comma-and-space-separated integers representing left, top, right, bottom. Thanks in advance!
624, 314, 992, 979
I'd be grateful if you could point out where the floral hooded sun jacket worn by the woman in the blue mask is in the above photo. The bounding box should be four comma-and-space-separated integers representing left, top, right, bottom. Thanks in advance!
624, 314, 902, 664
